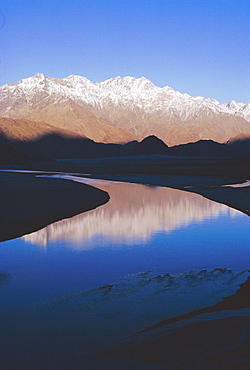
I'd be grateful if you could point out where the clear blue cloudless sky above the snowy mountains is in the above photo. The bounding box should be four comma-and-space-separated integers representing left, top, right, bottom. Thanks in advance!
0, 0, 250, 103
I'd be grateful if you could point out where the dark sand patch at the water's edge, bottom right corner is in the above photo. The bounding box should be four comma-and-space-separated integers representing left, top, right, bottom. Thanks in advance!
99, 315, 250, 370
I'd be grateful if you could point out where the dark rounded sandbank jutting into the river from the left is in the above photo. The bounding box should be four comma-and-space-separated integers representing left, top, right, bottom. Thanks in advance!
0, 172, 109, 242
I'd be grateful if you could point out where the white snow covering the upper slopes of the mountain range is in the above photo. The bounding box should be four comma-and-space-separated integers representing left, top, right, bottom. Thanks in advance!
1, 73, 250, 120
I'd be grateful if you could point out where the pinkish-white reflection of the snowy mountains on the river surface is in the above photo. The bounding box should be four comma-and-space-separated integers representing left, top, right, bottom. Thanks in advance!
23, 181, 237, 249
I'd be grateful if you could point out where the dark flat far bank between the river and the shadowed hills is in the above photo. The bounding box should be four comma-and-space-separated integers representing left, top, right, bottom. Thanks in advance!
2, 155, 250, 215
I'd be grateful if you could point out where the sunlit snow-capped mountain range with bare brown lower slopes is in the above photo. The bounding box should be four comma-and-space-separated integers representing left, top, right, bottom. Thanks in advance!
0, 73, 250, 145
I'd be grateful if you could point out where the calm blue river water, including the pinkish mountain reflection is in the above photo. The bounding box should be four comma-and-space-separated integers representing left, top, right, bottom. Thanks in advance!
0, 180, 250, 369
